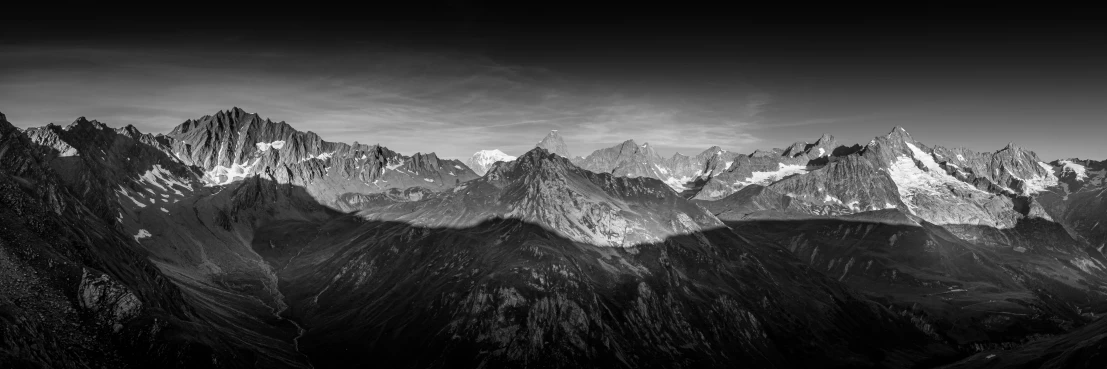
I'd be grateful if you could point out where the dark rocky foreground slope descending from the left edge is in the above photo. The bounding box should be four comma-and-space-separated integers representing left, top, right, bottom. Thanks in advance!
0, 110, 269, 368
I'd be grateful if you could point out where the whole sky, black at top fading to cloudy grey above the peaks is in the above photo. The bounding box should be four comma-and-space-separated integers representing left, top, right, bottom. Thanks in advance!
0, 1, 1107, 160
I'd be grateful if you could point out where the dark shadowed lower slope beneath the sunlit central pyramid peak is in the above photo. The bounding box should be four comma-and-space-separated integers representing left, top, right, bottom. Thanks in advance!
213, 178, 961, 368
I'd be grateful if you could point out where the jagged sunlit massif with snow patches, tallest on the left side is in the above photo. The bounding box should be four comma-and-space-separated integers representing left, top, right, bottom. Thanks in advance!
168, 107, 478, 204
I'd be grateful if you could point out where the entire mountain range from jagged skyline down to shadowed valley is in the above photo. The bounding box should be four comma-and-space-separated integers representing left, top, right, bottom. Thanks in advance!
0, 107, 1107, 368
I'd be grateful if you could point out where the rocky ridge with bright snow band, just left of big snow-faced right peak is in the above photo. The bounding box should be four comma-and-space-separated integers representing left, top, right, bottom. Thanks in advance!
695, 134, 842, 199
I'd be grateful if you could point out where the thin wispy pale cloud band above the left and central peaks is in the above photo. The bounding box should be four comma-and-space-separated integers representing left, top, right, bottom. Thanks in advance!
0, 43, 769, 157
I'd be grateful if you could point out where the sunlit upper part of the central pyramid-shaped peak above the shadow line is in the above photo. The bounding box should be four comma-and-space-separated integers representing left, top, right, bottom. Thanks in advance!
361, 148, 722, 246
